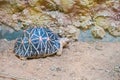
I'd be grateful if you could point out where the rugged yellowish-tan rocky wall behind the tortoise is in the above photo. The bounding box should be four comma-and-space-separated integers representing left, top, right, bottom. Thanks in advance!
0, 0, 120, 40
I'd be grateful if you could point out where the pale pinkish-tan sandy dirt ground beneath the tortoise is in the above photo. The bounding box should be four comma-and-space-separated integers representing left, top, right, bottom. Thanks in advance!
0, 40, 120, 80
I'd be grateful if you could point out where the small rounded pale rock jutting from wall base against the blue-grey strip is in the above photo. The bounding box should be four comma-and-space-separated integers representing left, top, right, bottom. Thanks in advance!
91, 26, 105, 38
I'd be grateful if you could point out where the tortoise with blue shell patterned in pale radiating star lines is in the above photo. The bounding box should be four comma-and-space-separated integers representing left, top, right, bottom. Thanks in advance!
14, 26, 69, 60
